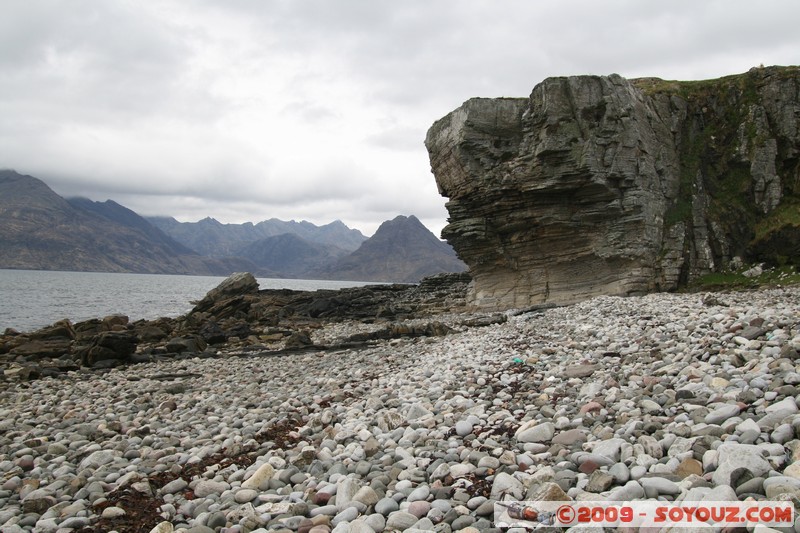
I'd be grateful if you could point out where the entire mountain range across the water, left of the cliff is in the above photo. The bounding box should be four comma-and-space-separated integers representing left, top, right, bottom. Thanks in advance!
0, 170, 466, 282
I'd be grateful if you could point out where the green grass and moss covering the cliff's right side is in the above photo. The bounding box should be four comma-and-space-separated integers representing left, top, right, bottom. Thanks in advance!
644, 67, 800, 284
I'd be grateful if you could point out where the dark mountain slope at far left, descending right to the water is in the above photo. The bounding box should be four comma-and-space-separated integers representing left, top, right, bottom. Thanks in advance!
0, 170, 255, 275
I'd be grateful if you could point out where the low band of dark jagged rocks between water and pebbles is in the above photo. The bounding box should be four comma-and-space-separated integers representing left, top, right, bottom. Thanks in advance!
0, 273, 470, 380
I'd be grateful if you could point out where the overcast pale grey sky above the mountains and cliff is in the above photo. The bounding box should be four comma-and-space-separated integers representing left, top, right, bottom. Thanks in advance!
0, 0, 800, 236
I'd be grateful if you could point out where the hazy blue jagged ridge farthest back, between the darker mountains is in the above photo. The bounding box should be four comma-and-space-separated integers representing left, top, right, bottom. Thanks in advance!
147, 217, 367, 262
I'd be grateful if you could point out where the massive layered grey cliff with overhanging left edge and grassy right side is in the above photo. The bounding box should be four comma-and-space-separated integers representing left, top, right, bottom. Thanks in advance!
425, 67, 800, 308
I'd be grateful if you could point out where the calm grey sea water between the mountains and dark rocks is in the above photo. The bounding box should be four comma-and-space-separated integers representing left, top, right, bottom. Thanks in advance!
0, 269, 376, 332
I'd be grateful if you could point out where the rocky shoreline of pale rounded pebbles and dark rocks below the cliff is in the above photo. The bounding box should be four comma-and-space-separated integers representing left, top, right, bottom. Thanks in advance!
0, 279, 800, 533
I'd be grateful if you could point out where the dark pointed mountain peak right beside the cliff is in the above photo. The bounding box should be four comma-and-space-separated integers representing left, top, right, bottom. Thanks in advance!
318, 216, 467, 283
